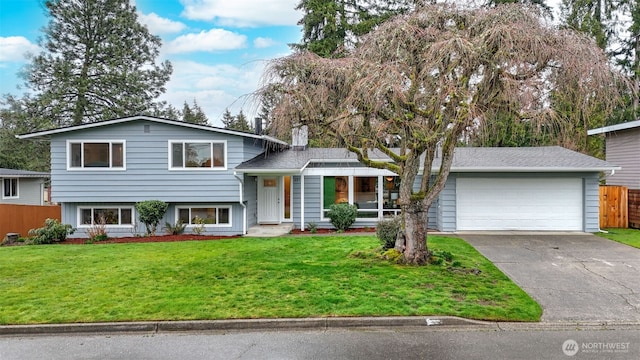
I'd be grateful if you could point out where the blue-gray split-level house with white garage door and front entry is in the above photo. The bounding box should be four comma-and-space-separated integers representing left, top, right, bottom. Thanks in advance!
18, 116, 619, 237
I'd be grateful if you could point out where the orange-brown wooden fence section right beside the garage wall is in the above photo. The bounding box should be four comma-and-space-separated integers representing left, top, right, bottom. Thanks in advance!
600, 185, 629, 229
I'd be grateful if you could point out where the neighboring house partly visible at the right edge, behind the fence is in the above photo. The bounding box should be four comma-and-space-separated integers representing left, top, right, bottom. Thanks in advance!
587, 120, 640, 189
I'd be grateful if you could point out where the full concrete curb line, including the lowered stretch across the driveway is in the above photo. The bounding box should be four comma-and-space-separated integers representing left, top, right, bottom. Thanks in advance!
0, 316, 640, 336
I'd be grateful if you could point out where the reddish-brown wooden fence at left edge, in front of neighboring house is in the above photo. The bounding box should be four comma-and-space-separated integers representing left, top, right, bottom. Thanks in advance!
0, 204, 60, 242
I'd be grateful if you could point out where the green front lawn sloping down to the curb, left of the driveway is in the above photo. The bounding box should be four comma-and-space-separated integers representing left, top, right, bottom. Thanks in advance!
0, 236, 542, 324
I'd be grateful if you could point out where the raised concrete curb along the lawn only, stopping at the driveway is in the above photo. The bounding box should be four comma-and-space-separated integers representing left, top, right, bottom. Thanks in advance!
0, 316, 495, 336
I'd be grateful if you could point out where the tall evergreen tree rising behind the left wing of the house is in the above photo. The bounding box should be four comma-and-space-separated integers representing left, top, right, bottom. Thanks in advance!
24, 0, 172, 126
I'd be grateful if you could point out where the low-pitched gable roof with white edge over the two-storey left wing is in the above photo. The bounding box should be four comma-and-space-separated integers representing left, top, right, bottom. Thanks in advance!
16, 115, 288, 145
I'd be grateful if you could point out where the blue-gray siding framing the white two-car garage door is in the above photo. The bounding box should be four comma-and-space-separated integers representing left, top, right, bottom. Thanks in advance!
437, 173, 600, 232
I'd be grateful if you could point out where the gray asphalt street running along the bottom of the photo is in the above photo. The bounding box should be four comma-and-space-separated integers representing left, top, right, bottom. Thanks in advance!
0, 324, 640, 360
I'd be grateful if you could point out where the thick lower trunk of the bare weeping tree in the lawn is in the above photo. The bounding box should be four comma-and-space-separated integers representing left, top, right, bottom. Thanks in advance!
395, 200, 429, 265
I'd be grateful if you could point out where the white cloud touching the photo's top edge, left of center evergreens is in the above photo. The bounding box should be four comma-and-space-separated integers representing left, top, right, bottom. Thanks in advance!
180, 0, 302, 27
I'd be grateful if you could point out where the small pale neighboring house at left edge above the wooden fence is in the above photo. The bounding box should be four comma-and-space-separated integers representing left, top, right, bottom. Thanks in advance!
0, 168, 49, 205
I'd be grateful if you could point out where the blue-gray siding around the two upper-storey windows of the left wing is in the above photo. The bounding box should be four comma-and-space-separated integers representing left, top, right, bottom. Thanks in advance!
51, 120, 262, 203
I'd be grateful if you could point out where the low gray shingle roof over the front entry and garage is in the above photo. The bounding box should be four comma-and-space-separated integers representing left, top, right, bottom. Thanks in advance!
236, 146, 620, 173
